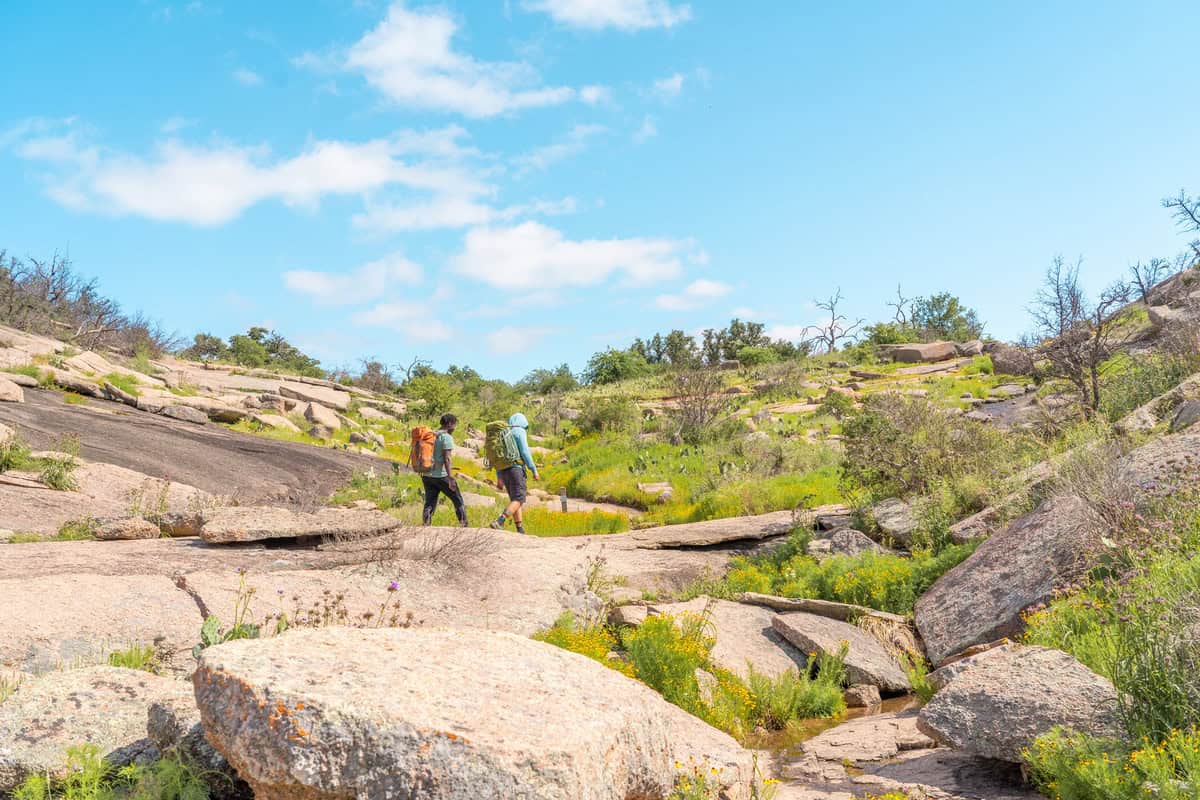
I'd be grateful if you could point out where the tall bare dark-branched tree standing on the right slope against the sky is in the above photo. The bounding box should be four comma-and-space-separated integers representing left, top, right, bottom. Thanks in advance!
1030, 257, 1130, 416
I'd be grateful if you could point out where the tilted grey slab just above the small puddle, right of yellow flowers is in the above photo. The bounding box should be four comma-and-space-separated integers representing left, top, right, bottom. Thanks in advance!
772, 612, 912, 692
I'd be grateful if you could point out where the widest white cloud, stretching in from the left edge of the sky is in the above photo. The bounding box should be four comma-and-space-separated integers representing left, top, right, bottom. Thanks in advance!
5, 120, 482, 225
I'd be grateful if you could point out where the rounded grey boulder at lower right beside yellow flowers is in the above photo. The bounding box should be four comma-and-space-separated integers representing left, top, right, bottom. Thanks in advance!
918, 645, 1122, 763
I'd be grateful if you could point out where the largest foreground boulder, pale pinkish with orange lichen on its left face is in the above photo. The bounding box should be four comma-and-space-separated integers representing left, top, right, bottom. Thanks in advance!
193, 628, 751, 800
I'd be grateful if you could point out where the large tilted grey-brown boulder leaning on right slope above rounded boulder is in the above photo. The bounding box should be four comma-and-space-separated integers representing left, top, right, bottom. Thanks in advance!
916, 498, 1103, 666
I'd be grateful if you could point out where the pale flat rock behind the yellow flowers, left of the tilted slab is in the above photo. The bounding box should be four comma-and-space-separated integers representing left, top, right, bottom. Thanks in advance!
649, 597, 808, 679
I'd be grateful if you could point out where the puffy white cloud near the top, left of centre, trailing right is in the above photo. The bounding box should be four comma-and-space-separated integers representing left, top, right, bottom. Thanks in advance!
336, 0, 576, 118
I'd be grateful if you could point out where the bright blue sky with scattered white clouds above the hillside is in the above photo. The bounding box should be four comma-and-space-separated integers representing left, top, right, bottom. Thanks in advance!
0, 0, 1200, 378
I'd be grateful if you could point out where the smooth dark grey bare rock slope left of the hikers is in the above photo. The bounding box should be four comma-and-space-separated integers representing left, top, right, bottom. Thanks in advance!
0, 389, 389, 505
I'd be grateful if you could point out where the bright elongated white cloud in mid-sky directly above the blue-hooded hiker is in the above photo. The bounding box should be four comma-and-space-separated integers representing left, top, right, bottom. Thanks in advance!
452, 222, 695, 290
